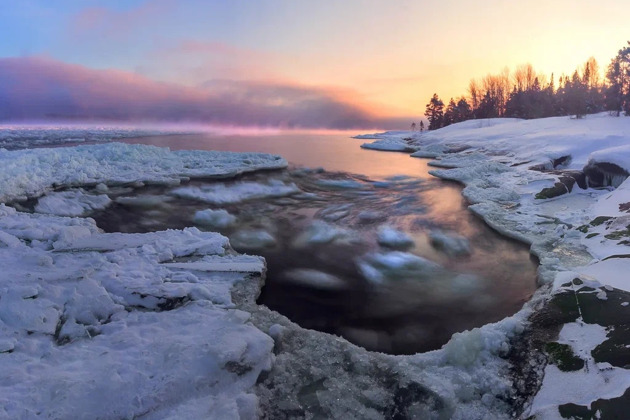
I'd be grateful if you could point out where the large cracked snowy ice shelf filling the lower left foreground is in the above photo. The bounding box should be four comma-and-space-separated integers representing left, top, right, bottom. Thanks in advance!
0, 205, 273, 418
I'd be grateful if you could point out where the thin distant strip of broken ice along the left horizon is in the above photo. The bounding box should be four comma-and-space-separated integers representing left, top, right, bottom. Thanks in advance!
0, 124, 193, 149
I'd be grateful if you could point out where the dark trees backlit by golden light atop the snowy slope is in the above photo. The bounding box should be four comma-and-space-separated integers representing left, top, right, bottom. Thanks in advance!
420, 41, 630, 130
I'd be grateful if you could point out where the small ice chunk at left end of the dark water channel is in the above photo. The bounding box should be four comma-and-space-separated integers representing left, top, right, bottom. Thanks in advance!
35, 189, 111, 216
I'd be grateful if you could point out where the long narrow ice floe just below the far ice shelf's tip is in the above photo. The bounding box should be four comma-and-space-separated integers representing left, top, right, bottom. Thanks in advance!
171, 180, 300, 204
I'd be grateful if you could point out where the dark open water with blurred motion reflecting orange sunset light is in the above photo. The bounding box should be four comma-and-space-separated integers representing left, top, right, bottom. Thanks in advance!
110, 135, 536, 354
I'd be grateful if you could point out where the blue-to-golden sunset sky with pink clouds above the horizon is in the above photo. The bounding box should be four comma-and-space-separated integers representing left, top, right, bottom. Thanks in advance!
0, 0, 630, 129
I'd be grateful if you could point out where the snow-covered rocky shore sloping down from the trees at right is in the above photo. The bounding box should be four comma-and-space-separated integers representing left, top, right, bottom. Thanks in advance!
364, 114, 630, 419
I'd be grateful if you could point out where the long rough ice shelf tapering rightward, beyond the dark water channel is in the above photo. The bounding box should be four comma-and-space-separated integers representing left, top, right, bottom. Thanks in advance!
0, 143, 287, 202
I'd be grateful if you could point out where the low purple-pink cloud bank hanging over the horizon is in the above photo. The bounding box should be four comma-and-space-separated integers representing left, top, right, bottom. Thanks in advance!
0, 57, 410, 129
